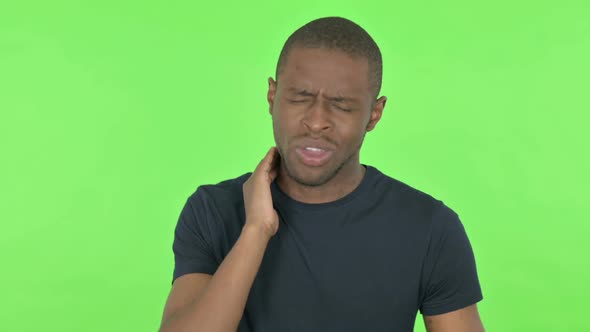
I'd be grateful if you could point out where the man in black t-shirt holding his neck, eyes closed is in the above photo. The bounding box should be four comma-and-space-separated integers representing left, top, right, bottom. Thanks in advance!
160, 17, 484, 332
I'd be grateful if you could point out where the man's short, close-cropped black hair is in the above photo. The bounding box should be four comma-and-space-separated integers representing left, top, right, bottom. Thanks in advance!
275, 16, 383, 99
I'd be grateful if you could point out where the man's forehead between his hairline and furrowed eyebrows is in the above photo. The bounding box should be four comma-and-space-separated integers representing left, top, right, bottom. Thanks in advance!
279, 47, 370, 95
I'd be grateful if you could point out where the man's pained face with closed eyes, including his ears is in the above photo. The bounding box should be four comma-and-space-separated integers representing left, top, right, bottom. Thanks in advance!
268, 47, 385, 186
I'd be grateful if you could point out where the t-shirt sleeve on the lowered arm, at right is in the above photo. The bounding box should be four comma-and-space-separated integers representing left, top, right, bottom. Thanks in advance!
420, 203, 483, 316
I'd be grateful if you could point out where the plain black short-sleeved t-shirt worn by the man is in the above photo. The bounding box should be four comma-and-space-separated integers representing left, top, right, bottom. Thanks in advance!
172, 165, 483, 332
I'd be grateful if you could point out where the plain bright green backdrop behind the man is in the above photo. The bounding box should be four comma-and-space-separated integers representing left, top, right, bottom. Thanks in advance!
0, 0, 590, 331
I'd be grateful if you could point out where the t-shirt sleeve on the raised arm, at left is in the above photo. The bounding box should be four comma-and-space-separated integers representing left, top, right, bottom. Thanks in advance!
172, 188, 218, 283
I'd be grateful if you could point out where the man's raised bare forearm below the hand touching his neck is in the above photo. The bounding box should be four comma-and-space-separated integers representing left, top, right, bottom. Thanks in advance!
160, 225, 269, 332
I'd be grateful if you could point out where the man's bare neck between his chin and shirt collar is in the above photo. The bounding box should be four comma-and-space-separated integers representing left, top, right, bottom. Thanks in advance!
277, 161, 366, 204
